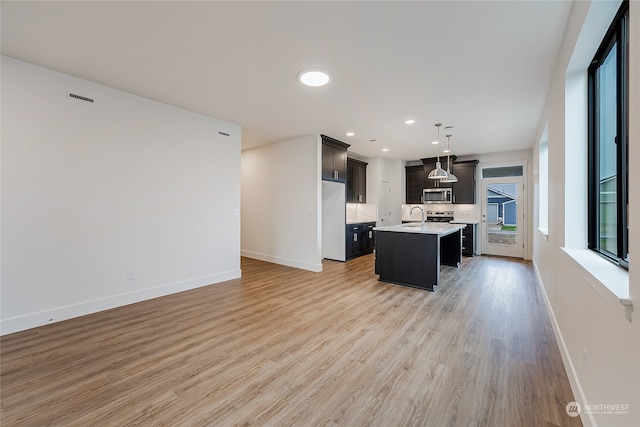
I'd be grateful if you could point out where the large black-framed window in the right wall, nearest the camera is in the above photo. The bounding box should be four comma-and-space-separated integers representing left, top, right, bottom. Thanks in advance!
588, 1, 629, 267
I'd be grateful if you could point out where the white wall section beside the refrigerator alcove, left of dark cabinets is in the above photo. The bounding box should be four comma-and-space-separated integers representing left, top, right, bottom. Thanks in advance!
241, 135, 322, 271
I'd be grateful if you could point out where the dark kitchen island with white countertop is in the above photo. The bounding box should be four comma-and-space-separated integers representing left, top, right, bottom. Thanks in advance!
374, 222, 465, 291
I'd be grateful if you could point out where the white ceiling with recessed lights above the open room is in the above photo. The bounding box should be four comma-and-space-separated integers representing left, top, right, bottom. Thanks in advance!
1, 0, 572, 160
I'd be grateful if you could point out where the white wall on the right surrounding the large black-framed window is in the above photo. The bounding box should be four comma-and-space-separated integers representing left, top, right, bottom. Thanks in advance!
532, 1, 640, 426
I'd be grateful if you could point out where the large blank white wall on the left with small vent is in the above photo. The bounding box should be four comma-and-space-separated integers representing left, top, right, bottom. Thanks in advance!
1, 57, 241, 334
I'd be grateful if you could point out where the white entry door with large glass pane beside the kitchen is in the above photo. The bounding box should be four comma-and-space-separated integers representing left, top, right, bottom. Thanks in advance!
480, 177, 524, 258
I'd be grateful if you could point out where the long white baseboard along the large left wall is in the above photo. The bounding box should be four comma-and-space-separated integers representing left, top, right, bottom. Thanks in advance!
0, 269, 241, 335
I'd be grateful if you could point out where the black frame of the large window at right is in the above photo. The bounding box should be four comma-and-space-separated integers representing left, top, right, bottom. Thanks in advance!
587, 0, 629, 269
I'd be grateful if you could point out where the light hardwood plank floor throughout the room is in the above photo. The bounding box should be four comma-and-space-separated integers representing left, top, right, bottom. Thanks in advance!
0, 255, 580, 427
